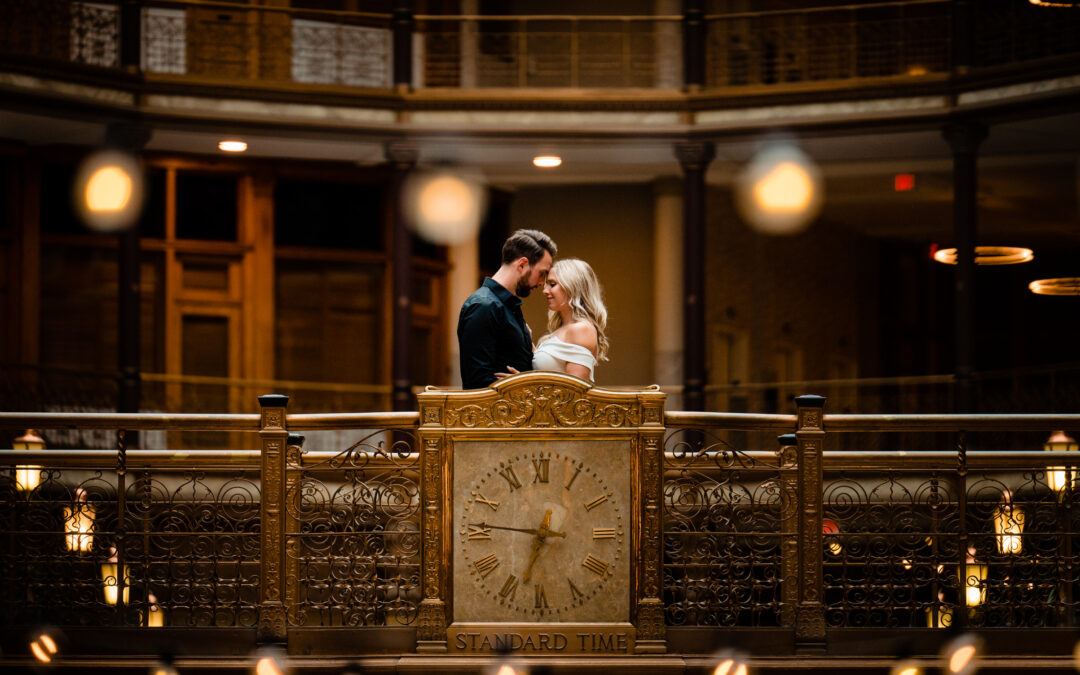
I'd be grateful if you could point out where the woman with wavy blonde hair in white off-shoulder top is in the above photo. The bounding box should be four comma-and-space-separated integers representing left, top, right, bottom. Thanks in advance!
532, 258, 608, 381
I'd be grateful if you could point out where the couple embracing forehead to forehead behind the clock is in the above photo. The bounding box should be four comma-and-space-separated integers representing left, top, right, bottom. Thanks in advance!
458, 230, 608, 389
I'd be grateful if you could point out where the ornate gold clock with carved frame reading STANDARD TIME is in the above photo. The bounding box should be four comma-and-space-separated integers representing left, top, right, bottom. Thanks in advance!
417, 373, 666, 656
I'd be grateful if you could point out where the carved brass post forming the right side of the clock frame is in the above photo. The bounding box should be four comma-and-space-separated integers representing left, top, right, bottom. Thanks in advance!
634, 386, 667, 653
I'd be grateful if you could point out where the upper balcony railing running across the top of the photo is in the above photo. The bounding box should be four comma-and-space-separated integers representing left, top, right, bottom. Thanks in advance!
0, 0, 1080, 94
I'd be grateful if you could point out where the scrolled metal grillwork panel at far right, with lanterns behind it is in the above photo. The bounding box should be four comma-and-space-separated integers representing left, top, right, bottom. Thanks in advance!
824, 469, 1080, 627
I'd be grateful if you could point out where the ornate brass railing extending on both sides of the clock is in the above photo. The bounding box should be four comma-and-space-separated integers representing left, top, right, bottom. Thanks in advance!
0, 396, 1080, 651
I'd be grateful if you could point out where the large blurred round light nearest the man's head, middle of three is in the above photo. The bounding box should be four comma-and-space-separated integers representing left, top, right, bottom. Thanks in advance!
404, 170, 487, 245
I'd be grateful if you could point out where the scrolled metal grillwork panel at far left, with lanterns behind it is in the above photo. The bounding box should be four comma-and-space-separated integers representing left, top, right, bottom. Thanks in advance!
0, 460, 259, 626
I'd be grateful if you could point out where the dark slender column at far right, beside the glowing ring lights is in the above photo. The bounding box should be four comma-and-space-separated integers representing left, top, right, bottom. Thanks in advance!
944, 122, 986, 413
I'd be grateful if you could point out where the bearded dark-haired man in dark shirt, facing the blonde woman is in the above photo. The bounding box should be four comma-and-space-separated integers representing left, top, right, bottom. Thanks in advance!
458, 230, 556, 389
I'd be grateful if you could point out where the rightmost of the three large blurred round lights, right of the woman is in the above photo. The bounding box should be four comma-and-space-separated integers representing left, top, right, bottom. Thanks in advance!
735, 143, 822, 235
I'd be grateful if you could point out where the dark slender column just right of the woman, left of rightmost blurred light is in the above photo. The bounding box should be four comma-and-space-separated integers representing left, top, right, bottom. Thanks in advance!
675, 143, 716, 410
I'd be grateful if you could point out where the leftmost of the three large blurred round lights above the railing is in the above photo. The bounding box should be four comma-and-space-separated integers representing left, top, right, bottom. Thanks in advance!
73, 150, 144, 232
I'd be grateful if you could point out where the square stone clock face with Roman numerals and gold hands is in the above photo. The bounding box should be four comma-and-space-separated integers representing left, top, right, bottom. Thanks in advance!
454, 441, 631, 622
